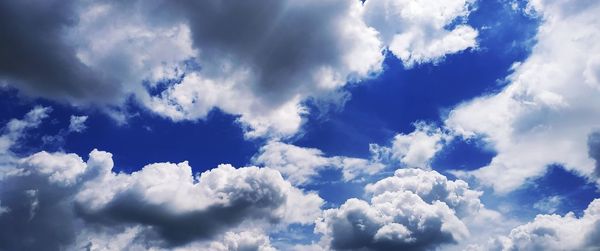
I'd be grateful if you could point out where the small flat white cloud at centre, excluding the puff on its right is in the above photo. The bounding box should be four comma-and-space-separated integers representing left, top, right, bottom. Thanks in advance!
253, 141, 385, 184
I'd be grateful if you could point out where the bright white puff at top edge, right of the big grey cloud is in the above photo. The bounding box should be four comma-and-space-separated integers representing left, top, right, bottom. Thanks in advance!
364, 0, 477, 67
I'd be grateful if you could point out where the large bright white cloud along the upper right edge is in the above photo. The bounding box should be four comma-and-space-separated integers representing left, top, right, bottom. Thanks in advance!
445, 1, 600, 193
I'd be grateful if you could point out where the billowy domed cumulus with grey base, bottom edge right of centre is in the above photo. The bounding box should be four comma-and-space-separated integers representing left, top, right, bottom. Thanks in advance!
315, 169, 482, 250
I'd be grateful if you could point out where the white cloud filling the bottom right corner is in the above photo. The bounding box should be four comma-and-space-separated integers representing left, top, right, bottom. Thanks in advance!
480, 199, 600, 250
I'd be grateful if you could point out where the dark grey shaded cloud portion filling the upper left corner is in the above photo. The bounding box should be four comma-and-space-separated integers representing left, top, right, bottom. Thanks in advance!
0, 0, 122, 104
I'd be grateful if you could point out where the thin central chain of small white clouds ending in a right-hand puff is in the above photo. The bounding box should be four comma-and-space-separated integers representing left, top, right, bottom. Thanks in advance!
252, 122, 452, 185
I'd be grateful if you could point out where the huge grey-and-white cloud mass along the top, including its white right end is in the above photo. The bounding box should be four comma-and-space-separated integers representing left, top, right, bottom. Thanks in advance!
0, 0, 477, 137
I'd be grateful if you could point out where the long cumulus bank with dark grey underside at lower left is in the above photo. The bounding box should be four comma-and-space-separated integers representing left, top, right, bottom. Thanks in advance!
0, 144, 323, 250
